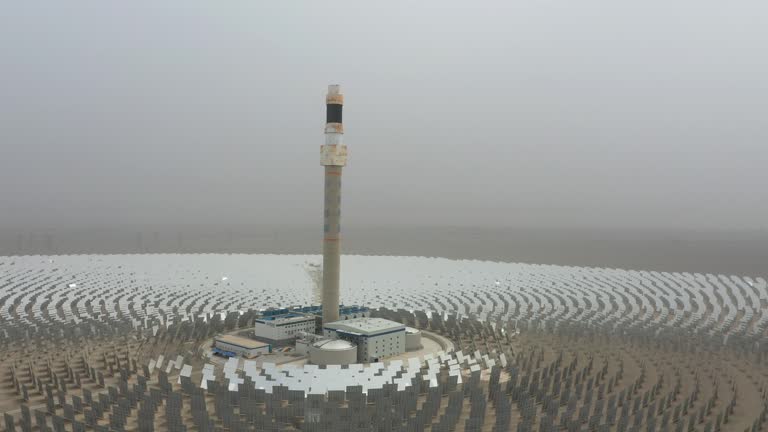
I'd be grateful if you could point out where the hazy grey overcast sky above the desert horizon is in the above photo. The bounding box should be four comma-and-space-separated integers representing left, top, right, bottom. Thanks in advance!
0, 0, 768, 228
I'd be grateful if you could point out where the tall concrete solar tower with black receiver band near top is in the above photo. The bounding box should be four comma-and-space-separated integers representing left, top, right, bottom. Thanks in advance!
320, 85, 347, 323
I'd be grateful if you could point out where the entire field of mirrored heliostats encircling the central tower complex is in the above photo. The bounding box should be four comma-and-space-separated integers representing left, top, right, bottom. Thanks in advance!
0, 254, 768, 431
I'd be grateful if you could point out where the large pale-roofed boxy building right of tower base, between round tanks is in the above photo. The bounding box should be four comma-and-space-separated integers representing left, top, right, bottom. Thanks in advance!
323, 318, 405, 363
